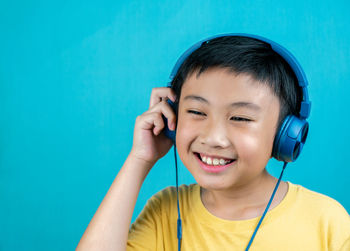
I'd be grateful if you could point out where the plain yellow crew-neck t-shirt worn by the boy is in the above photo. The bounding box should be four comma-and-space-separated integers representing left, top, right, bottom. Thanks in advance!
127, 182, 350, 251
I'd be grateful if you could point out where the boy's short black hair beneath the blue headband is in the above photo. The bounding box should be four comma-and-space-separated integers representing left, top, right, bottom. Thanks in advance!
171, 36, 303, 132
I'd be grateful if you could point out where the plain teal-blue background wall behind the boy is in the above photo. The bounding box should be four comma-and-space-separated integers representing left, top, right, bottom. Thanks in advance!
0, 0, 350, 250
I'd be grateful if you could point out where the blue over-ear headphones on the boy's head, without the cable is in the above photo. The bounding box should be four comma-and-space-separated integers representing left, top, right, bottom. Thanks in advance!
164, 33, 311, 162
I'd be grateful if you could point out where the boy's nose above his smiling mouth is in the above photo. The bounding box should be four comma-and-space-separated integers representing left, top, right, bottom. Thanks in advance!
200, 118, 230, 148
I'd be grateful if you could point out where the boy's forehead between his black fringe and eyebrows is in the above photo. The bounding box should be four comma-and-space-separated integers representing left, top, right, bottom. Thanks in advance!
180, 68, 279, 111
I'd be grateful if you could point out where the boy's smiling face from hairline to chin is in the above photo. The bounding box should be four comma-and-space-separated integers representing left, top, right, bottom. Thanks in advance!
176, 68, 280, 190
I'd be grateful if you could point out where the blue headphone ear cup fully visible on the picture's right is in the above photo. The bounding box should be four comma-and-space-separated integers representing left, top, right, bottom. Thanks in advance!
272, 115, 309, 162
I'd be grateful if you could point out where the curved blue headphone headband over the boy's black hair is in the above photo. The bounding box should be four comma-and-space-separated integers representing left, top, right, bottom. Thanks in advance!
170, 33, 311, 119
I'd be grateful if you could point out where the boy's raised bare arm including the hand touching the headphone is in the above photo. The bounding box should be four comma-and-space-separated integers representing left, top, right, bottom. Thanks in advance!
76, 87, 176, 251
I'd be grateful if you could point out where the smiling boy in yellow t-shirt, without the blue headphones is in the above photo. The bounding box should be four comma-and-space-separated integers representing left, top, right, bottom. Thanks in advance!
77, 36, 350, 250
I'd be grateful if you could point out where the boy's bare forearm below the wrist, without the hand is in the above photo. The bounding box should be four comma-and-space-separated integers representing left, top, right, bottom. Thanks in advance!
76, 155, 152, 251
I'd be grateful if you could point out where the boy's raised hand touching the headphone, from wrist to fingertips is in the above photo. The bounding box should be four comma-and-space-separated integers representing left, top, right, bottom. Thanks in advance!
130, 87, 176, 167
